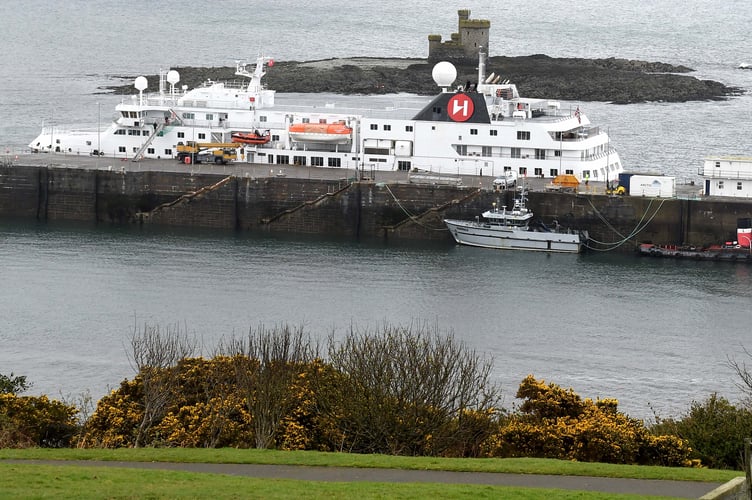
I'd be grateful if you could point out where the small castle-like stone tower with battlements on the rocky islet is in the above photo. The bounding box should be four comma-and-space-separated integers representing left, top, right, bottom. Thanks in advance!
428, 9, 491, 61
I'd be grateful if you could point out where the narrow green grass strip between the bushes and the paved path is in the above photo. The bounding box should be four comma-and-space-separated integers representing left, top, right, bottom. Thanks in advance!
0, 448, 742, 482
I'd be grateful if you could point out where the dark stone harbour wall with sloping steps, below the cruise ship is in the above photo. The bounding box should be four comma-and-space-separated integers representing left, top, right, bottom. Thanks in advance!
0, 165, 752, 251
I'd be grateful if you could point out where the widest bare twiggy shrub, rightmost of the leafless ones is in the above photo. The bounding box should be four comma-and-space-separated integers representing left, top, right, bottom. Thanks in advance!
316, 325, 500, 456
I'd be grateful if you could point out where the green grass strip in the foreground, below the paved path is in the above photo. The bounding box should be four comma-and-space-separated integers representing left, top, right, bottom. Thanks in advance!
0, 462, 680, 500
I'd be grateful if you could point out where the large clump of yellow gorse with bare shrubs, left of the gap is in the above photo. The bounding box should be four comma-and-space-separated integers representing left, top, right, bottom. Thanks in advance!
78, 327, 500, 456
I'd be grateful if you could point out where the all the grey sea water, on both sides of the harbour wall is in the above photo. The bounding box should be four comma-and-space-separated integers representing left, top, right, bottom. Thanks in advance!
0, 0, 752, 419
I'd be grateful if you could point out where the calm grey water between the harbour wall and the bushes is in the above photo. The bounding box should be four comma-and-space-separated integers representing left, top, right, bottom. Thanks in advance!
0, 223, 752, 417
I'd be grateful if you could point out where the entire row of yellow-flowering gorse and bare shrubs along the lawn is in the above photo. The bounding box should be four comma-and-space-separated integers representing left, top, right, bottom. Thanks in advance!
14, 325, 752, 468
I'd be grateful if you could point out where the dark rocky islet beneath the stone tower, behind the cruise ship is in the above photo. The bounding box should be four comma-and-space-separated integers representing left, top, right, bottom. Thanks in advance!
106, 54, 744, 104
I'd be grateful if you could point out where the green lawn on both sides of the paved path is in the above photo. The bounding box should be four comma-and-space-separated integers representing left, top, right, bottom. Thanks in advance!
0, 448, 742, 500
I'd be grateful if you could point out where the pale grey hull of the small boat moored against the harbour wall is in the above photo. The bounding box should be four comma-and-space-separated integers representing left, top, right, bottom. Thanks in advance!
444, 219, 584, 253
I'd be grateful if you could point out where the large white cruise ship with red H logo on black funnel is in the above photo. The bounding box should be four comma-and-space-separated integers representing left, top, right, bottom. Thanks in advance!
29, 51, 623, 181
